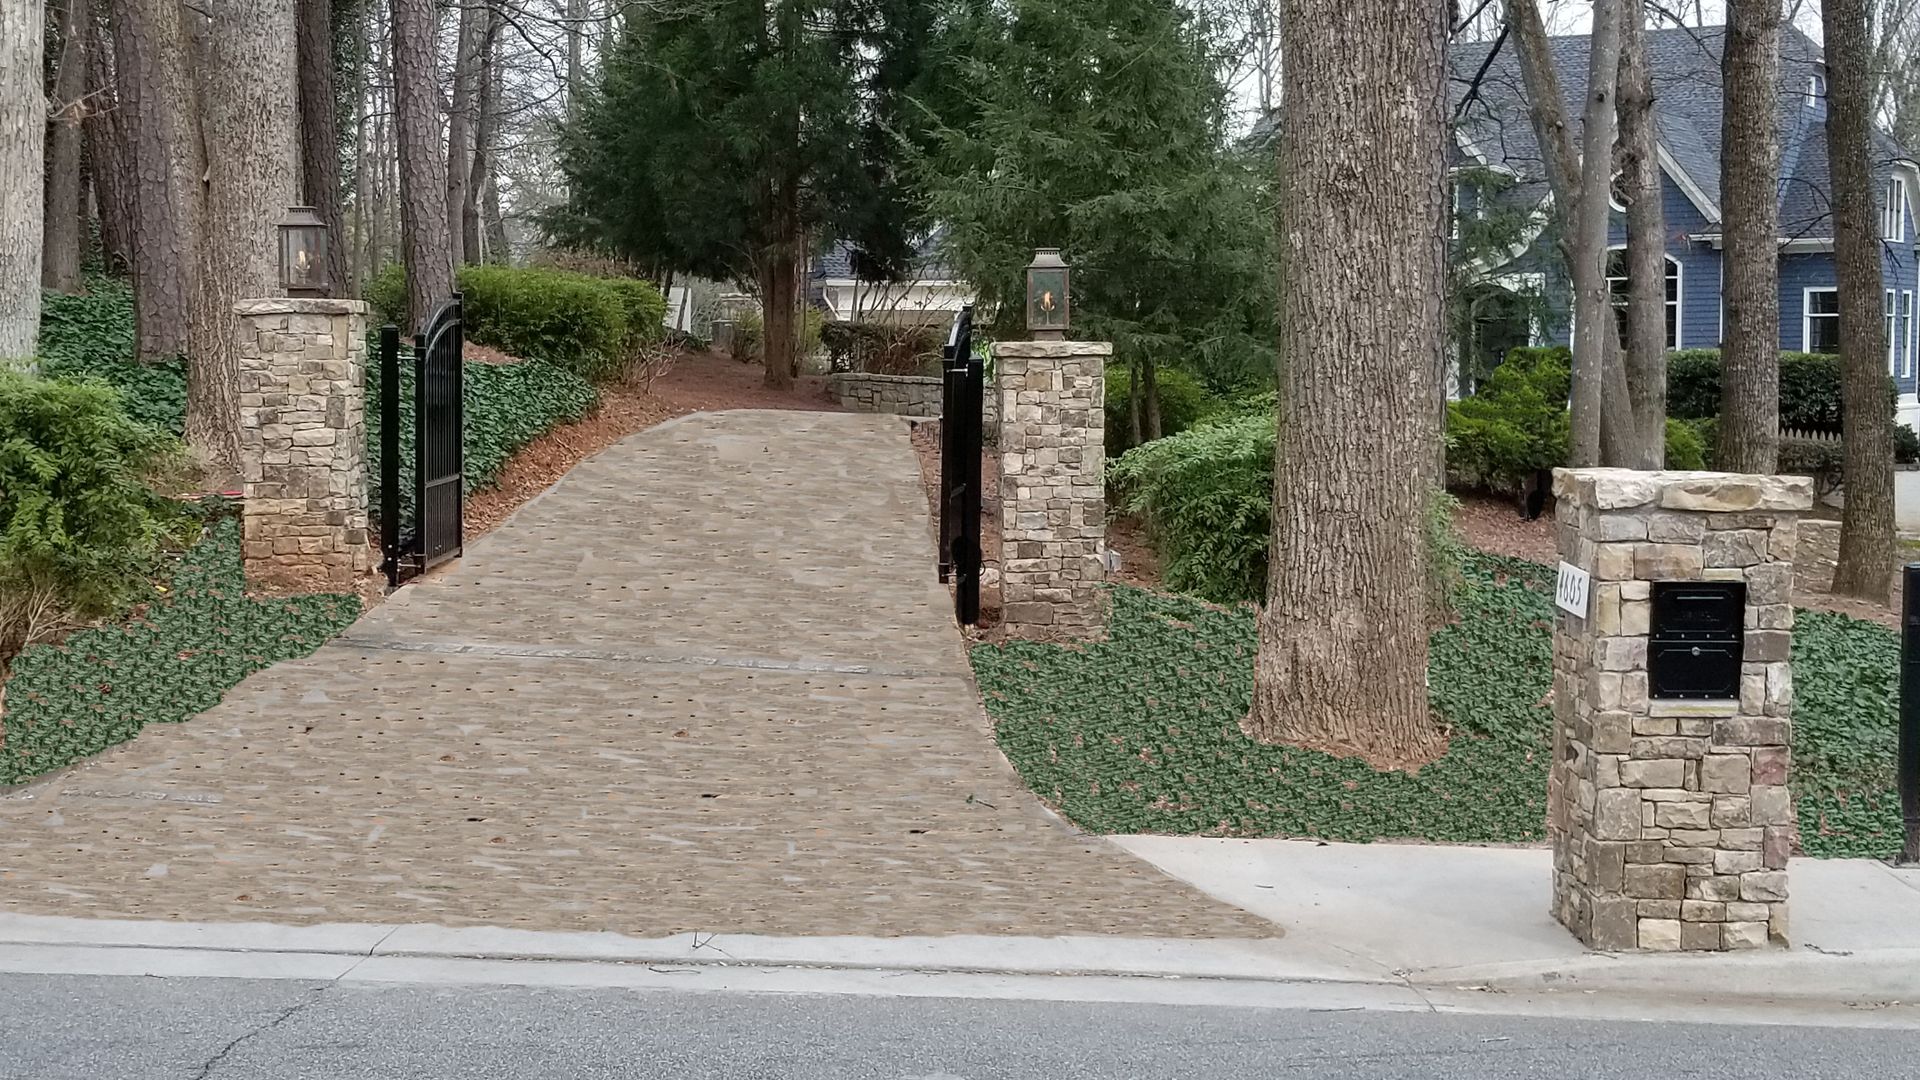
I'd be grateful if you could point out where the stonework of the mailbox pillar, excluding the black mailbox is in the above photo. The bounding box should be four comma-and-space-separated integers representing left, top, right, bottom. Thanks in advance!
1548, 469, 1812, 951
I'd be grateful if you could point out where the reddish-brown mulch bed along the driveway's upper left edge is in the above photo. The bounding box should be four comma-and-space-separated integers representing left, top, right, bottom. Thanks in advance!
465, 346, 839, 540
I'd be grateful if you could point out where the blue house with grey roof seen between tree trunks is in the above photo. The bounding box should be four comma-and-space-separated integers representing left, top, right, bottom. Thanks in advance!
1450, 27, 1920, 427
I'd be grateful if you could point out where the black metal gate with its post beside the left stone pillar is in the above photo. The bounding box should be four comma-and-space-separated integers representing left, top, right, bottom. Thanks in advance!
380, 292, 465, 586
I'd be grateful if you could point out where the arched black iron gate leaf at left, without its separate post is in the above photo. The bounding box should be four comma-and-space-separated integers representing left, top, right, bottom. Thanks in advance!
413, 292, 467, 571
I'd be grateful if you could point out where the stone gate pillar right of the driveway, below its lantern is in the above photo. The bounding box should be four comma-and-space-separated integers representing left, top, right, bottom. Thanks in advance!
993, 342, 1114, 636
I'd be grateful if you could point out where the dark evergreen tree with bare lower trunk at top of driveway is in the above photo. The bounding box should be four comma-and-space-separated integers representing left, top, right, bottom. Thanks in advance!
545, 0, 931, 386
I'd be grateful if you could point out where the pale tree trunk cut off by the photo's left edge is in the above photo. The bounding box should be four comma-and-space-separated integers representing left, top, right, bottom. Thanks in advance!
0, 0, 46, 367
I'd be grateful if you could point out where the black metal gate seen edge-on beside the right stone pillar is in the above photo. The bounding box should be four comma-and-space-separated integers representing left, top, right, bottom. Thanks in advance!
939, 306, 987, 626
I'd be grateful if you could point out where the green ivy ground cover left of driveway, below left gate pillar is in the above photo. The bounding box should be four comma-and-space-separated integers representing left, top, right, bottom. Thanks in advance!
0, 515, 359, 786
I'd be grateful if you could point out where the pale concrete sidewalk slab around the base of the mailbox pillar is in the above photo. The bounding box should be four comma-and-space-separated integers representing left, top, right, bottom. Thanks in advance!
1114, 836, 1920, 1001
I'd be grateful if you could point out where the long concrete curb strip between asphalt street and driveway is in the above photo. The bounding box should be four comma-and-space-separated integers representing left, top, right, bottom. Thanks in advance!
0, 913, 1920, 1003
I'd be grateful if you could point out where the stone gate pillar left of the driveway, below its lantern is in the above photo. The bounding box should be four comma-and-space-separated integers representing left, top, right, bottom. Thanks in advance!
234, 298, 372, 586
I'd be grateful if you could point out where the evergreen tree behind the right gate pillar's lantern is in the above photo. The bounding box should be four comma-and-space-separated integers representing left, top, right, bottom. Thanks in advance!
920, 0, 1275, 411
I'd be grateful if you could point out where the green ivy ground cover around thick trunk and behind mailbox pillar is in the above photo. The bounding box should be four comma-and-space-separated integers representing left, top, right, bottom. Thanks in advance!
972, 555, 1899, 857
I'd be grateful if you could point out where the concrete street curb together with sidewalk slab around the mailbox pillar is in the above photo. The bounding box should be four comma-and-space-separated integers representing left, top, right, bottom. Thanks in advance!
0, 836, 1920, 1006
